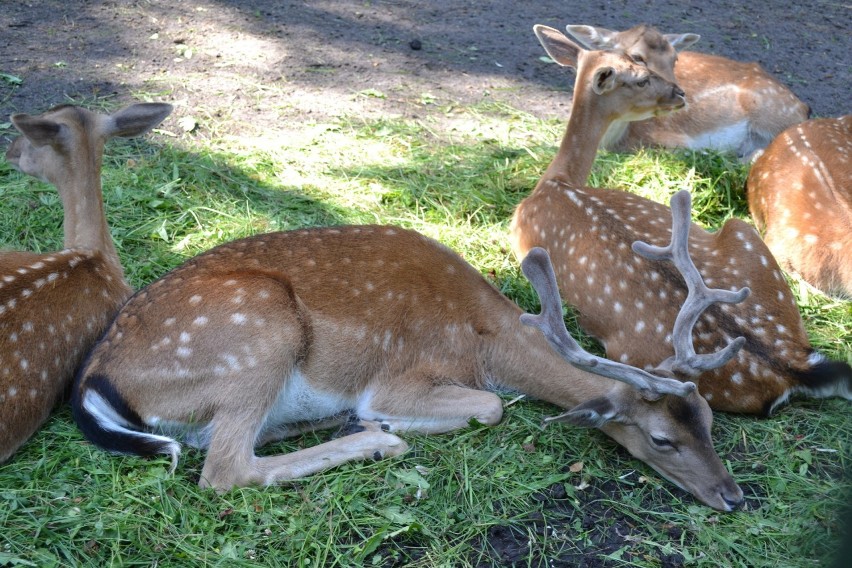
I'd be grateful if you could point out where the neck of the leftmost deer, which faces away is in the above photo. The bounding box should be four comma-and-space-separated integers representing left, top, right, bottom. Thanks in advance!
54, 152, 124, 276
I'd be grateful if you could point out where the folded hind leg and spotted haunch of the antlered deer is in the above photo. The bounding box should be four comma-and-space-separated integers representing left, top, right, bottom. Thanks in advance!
141, 270, 407, 491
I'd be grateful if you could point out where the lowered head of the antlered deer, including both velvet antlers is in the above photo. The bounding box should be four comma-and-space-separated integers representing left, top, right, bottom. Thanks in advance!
521, 191, 749, 510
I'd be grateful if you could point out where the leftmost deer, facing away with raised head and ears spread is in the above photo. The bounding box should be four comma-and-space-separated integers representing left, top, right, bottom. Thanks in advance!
0, 104, 171, 462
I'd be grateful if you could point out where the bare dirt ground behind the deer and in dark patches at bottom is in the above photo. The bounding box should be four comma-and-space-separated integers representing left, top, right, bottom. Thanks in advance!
0, 0, 852, 566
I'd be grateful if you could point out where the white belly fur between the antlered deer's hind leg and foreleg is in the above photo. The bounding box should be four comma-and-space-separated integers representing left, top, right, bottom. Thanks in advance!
263, 370, 355, 430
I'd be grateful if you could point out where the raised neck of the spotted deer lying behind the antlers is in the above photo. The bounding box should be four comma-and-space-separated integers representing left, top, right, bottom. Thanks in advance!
542, 87, 612, 187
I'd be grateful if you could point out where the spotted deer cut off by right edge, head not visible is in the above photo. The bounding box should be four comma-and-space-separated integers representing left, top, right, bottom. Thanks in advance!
746, 115, 852, 299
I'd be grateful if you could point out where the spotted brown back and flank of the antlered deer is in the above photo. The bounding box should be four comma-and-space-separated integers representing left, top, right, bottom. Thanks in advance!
88, 226, 520, 412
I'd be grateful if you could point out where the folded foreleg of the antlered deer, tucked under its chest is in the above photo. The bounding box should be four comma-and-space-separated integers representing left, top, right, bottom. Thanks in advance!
356, 372, 503, 434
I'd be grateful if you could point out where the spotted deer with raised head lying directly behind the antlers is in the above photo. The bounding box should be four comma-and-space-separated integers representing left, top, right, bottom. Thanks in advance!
511, 26, 852, 415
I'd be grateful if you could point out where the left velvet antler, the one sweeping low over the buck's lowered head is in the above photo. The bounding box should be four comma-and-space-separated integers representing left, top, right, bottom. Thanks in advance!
521, 248, 695, 399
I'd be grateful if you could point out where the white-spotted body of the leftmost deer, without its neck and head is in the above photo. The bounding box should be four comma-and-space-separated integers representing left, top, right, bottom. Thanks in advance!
0, 250, 129, 461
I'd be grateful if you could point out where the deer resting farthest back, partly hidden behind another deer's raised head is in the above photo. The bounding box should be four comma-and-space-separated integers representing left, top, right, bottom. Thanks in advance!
567, 25, 810, 161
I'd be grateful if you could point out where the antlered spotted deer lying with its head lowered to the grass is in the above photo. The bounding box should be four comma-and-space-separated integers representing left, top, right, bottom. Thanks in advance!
72, 210, 742, 510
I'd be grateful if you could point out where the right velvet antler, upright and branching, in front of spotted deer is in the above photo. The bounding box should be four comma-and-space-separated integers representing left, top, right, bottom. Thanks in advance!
633, 190, 751, 377
